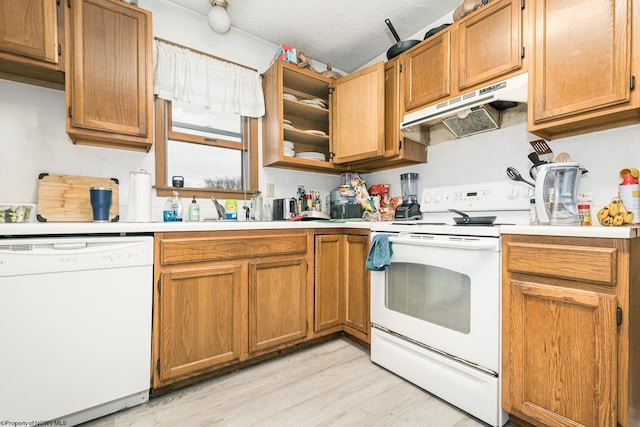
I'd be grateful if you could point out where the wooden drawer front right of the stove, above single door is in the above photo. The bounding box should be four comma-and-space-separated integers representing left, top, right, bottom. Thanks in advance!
505, 242, 617, 285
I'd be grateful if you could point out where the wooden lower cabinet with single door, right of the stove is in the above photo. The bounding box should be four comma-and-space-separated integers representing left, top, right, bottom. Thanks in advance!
502, 235, 640, 427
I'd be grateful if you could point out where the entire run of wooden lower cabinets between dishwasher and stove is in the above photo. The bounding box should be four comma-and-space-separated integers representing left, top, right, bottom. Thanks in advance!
152, 229, 370, 390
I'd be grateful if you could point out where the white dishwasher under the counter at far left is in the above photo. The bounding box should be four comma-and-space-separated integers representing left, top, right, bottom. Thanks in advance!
0, 236, 153, 426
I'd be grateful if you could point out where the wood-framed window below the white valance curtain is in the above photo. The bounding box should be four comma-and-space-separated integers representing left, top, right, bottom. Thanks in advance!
155, 98, 258, 199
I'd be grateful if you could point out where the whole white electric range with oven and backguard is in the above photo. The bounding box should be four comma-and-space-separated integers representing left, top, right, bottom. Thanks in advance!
371, 181, 531, 426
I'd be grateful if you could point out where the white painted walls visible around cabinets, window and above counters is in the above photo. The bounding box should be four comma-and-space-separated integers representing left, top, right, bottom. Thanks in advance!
0, 0, 640, 219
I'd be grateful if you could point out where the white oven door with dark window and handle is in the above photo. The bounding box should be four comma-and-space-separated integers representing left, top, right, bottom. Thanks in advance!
371, 234, 501, 374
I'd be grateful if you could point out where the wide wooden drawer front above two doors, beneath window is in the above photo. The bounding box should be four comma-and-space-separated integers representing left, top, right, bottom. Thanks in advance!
160, 234, 307, 264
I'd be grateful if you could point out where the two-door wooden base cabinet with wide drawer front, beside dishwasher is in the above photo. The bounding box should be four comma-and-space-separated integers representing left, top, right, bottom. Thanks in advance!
152, 230, 309, 388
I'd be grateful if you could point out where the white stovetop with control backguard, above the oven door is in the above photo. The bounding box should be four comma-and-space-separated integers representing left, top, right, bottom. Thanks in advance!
371, 180, 533, 237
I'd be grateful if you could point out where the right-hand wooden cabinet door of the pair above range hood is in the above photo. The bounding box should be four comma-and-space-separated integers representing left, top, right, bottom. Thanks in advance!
457, 0, 522, 91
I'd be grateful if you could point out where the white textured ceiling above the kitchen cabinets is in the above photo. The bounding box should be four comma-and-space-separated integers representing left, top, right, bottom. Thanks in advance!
166, 0, 461, 72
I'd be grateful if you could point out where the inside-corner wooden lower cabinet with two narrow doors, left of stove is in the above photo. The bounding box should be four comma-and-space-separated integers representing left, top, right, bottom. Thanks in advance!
314, 230, 370, 343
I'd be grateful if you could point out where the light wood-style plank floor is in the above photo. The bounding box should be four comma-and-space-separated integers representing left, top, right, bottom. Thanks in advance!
83, 338, 485, 427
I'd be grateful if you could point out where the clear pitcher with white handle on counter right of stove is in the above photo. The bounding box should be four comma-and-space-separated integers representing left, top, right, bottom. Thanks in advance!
535, 162, 582, 225
